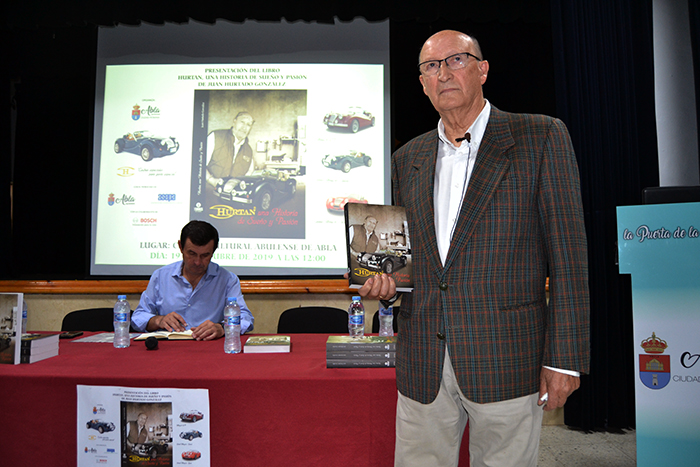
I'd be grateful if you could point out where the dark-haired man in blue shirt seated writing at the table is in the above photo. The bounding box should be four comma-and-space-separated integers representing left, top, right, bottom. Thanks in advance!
131, 221, 253, 340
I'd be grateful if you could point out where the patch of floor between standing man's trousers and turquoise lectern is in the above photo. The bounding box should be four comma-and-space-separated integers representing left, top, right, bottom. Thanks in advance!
538, 425, 637, 467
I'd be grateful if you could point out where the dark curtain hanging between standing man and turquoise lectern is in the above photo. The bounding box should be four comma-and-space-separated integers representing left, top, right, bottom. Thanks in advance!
552, 0, 659, 430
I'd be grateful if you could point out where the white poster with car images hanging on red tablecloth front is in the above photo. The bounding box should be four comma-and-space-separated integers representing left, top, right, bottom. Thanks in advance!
77, 385, 211, 467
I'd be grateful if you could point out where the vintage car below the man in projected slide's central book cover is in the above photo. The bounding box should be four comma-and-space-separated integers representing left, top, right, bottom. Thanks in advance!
214, 169, 297, 211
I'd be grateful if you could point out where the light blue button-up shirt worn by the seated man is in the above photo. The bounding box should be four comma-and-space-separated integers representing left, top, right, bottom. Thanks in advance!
131, 261, 254, 333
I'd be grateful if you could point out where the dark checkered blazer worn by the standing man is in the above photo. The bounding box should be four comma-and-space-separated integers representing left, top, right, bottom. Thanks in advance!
392, 107, 590, 403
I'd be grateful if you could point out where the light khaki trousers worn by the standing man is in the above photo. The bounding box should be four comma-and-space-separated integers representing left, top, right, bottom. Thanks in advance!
394, 352, 543, 467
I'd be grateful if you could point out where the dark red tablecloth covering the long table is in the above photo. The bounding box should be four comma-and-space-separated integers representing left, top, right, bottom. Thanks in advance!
0, 334, 467, 467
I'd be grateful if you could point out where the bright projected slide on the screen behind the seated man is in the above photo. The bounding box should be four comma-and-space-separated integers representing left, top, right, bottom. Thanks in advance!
91, 20, 389, 276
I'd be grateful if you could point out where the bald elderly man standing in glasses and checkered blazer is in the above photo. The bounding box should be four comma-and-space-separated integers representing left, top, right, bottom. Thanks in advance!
360, 31, 590, 467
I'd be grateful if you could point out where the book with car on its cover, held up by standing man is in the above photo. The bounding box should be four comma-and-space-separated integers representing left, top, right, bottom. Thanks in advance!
345, 203, 413, 292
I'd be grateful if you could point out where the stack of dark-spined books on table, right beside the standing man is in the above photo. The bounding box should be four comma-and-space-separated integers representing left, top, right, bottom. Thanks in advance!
326, 336, 396, 368
